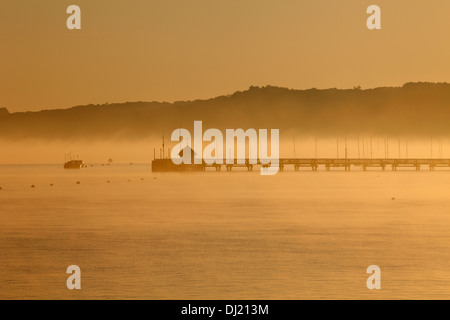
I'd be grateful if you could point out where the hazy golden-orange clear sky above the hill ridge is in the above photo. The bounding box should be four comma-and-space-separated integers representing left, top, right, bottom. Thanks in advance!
0, 0, 450, 112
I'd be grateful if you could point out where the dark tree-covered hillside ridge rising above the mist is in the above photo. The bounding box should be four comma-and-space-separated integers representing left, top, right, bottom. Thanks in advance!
0, 83, 450, 139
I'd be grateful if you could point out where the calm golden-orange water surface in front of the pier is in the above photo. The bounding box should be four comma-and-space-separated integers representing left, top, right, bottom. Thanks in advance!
0, 165, 450, 299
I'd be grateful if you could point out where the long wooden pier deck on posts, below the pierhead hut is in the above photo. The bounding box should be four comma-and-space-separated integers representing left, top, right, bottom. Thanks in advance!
152, 158, 450, 172
